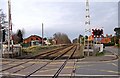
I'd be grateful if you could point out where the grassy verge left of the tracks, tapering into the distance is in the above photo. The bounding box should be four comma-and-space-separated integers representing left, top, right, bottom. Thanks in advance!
17, 45, 65, 58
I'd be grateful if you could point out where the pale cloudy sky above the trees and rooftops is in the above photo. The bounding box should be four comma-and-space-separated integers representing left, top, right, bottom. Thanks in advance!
0, 0, 119, 40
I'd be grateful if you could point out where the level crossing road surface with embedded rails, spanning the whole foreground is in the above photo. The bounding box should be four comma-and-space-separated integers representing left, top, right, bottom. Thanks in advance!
0, 58, 120, 78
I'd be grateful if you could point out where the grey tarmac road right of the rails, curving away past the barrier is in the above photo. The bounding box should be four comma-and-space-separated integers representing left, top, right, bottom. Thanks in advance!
75, 47, 120, 78
